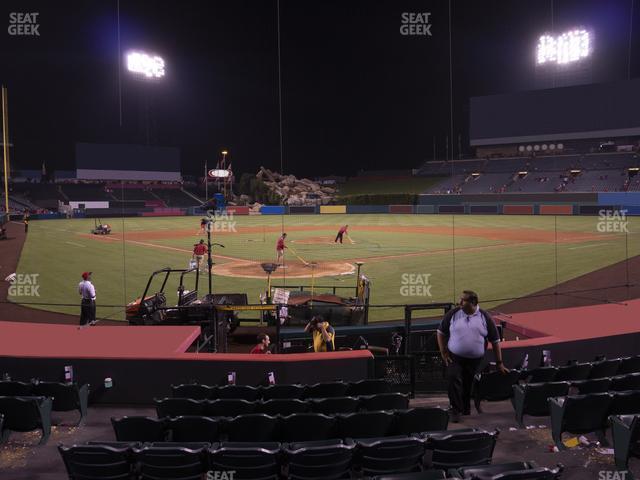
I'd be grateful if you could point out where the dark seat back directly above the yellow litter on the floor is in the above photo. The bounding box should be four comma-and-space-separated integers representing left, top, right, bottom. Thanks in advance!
562, 393, 612, 433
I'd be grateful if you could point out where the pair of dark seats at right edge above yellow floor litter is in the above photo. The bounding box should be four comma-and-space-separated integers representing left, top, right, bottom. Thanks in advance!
549, 390, 640, 449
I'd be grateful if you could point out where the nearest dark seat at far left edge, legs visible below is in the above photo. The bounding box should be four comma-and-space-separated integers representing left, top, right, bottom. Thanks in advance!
0, 397, 53, 445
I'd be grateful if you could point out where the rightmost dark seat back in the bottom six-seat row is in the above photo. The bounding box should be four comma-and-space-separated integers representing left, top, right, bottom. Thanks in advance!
427, 432, 497, 469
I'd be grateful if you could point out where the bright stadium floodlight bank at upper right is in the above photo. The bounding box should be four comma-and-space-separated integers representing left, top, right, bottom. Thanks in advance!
536, 29, 591, 65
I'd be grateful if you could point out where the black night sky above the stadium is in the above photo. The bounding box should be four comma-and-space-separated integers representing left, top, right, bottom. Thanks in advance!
0, 0, 640, 176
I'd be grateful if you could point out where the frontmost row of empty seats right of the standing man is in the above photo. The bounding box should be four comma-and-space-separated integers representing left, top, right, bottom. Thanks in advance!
520, 356, 640, 383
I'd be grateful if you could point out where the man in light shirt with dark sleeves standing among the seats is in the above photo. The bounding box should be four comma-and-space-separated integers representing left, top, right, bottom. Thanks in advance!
437, 290, 509, 423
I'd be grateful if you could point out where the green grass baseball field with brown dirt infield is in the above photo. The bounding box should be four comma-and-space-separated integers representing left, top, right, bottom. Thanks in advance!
10, 214, 640, 321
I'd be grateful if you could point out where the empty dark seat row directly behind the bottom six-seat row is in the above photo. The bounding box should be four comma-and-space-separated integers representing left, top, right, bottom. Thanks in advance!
111, 407, 449, 442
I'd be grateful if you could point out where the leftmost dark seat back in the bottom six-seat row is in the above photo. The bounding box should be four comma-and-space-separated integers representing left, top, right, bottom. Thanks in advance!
58, 445, 132, 480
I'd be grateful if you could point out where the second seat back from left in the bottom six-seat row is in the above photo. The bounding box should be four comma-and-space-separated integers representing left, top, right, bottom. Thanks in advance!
134, 447, 207, 480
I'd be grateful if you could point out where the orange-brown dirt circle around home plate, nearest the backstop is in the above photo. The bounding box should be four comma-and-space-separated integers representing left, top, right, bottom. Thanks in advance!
213, 261, 356, 279
